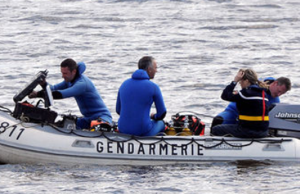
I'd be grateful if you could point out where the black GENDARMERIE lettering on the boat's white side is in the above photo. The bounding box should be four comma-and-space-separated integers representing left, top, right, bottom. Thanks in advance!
97, 141, 203, 156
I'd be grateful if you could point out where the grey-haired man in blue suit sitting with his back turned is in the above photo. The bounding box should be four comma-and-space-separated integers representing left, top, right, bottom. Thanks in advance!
116, 56, 167, 136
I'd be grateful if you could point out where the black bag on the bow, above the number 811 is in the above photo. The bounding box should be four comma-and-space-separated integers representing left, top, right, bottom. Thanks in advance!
13, 102, 57, 124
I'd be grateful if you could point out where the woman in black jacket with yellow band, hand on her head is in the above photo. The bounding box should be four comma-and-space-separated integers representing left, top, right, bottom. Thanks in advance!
211, 69, 269, 138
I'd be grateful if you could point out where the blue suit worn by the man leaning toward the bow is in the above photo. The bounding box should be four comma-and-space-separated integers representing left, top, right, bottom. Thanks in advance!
50, 62, 112, 129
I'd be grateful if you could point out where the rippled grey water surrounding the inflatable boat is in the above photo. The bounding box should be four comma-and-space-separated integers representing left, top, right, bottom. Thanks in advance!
0, 0, 300, 194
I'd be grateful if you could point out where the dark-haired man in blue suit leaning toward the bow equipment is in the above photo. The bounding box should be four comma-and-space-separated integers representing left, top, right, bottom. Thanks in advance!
28, 59, 112, 129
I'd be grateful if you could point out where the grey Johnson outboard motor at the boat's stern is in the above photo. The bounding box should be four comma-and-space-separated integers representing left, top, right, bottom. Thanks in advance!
269, 103, 300, 138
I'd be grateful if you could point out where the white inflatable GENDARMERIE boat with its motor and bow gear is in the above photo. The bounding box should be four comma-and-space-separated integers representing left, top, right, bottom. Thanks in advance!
0, 72, 300, 165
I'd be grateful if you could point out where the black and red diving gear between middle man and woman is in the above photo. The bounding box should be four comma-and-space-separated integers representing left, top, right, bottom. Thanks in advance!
171, 113, 205, 135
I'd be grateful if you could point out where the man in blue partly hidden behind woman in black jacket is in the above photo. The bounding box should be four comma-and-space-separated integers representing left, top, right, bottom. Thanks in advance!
211, 77, 291, 128
